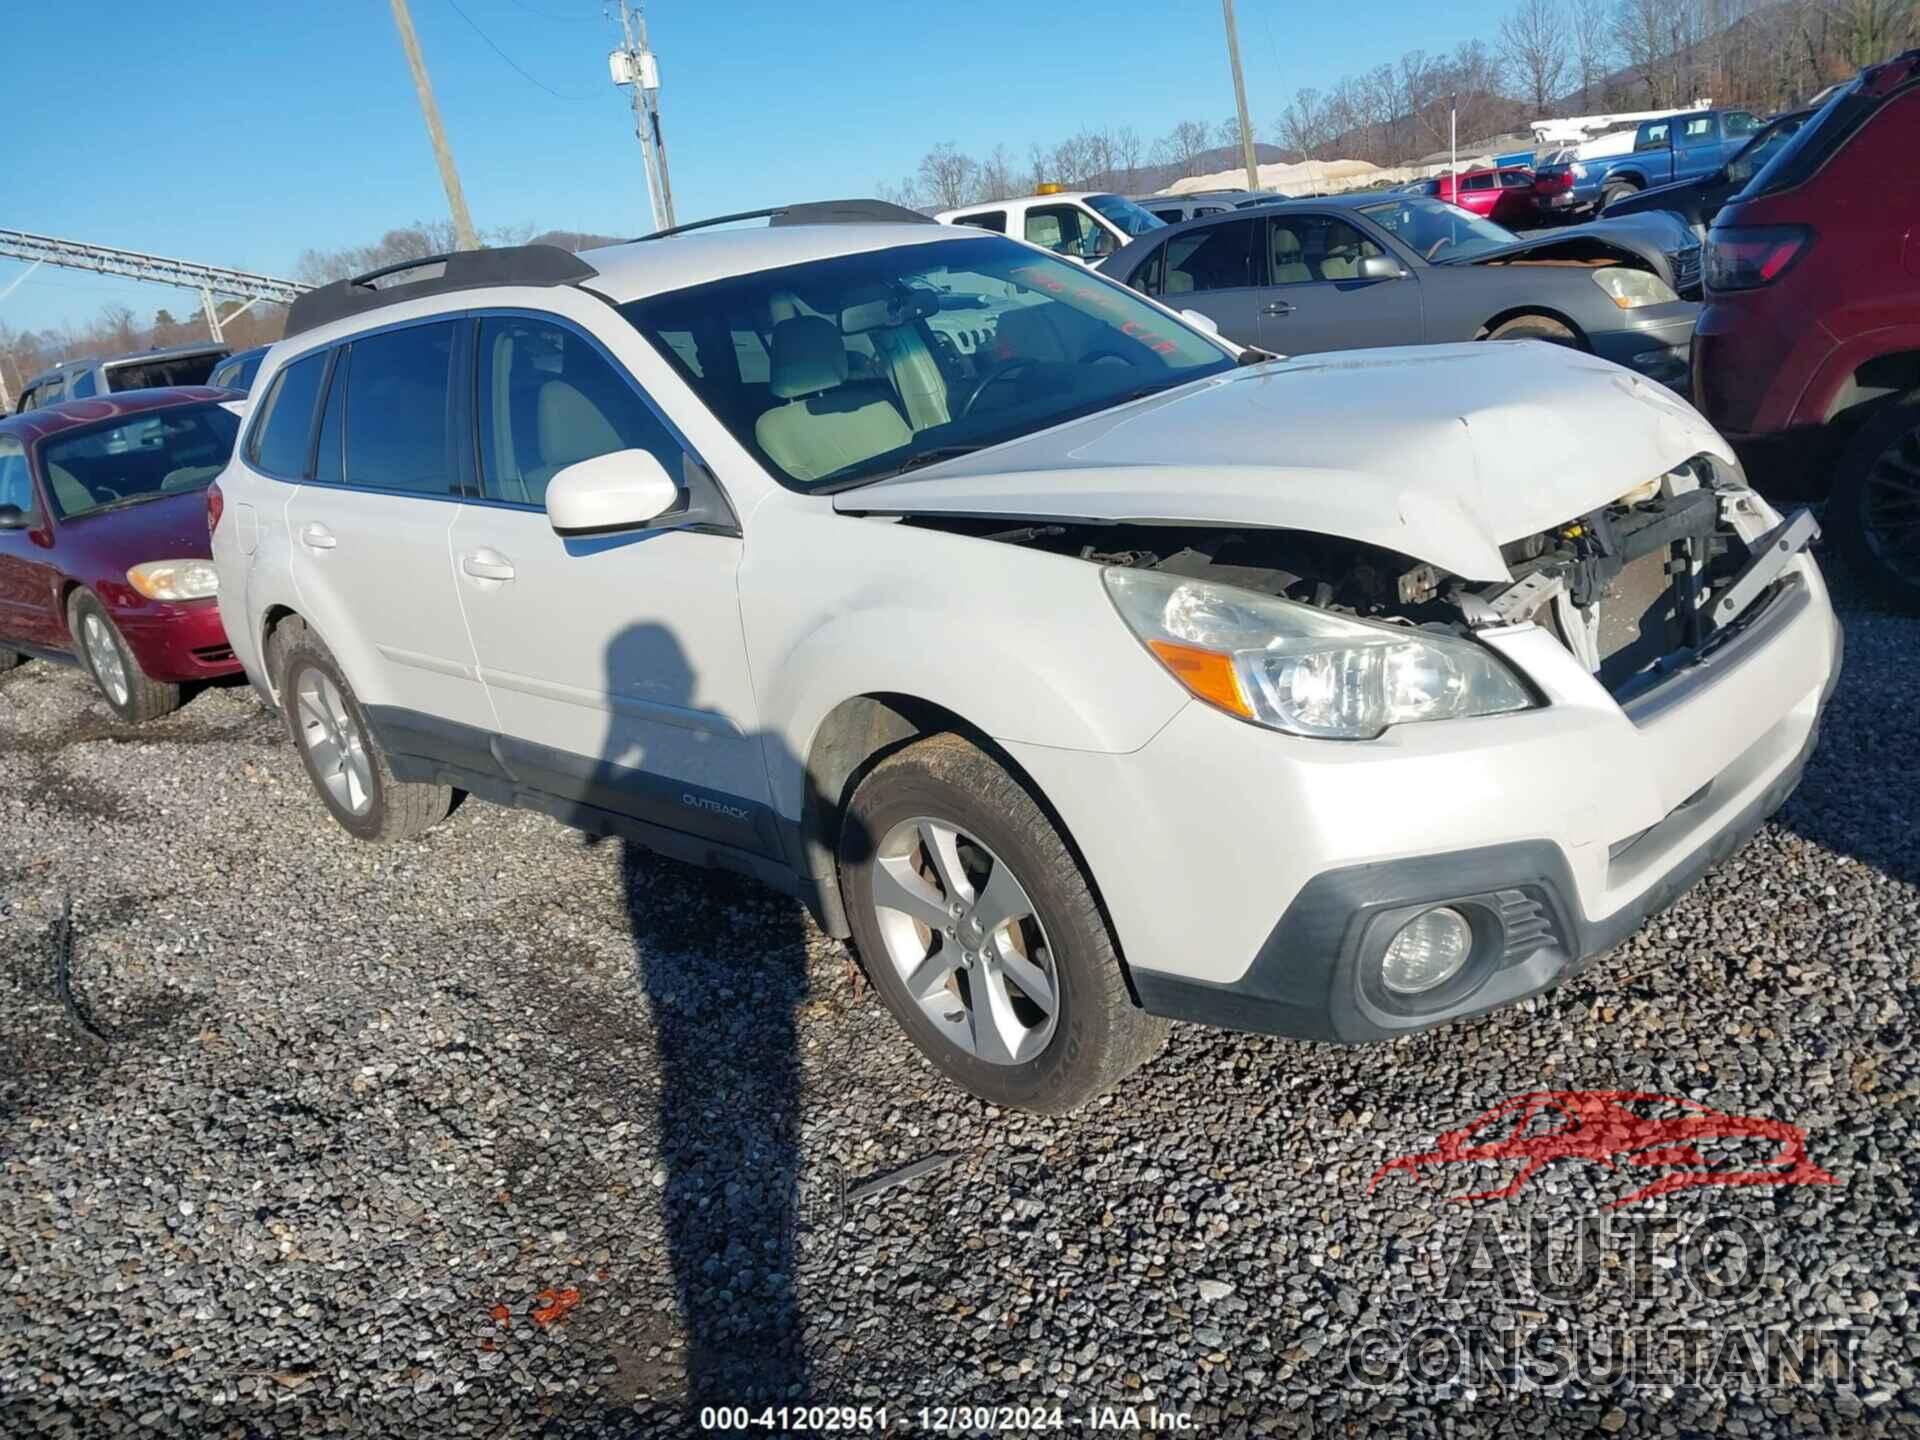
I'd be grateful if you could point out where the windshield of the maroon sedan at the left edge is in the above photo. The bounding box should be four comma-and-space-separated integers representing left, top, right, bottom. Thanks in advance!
40, 405, 240, 520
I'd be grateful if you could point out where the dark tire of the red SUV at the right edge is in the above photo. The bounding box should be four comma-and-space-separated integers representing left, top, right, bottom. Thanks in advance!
1824, 390, 1920, 614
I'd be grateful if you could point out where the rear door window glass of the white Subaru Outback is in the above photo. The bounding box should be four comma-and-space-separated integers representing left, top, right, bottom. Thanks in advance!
346, 321, 461, 495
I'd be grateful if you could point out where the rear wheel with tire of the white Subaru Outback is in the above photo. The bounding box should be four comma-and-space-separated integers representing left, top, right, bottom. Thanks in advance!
267, 620, 453, 843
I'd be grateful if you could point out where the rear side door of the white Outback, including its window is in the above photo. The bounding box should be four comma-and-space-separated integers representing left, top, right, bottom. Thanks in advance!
282, 319, 493, 737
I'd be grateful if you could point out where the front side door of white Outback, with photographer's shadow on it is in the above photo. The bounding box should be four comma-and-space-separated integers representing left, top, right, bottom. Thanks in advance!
453, 315, 778, 854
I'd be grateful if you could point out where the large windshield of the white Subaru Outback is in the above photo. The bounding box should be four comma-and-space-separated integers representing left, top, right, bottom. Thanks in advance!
620, 234, 1235, 490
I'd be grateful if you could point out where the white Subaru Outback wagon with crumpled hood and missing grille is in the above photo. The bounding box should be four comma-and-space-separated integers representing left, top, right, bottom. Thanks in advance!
209, 202, 1839, 1110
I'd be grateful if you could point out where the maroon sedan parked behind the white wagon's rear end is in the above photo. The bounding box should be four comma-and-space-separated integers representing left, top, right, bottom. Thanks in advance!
0, 388, 242, 720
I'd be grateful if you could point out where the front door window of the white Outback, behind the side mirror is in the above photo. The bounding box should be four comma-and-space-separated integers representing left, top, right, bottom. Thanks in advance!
480, 317, 682, 505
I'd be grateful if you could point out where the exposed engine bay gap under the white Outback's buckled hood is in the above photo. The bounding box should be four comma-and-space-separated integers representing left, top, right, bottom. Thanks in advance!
906, 457, 1818, 699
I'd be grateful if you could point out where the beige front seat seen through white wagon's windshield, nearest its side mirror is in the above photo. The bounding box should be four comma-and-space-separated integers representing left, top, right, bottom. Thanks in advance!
753, 315, 914, 480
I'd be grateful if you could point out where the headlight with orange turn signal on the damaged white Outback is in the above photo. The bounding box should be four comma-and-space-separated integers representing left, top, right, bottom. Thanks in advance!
1102, 568, 1534, 739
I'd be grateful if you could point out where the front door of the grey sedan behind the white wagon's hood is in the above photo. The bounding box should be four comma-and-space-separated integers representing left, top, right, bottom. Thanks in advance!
1256, 211, 1427, 355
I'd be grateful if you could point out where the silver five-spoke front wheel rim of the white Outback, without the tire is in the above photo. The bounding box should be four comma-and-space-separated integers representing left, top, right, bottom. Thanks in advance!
872, 816, 1060, 1066
